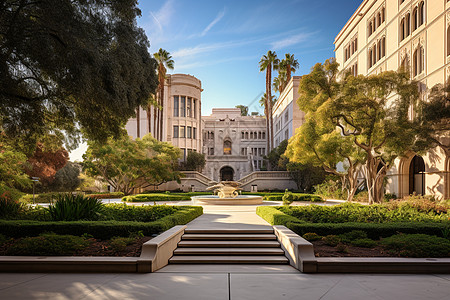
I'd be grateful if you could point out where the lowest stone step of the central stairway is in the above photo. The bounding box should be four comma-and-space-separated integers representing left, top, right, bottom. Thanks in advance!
169, 255, 289, 264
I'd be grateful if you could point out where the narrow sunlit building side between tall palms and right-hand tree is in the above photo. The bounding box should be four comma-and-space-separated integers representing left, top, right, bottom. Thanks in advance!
272, 76, 305, 148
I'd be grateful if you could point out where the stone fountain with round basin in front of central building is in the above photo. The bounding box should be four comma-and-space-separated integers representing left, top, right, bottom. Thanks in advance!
191, 181, 263, 205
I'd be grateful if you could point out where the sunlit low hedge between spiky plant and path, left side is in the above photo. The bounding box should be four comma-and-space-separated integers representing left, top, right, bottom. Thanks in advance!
100, 203, 179, 222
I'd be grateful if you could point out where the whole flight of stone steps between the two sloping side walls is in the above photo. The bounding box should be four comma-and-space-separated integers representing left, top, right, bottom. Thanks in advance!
169, 228, 289, 264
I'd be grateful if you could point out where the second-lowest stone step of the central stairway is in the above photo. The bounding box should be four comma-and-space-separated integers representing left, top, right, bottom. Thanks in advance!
174, 248, 284, 255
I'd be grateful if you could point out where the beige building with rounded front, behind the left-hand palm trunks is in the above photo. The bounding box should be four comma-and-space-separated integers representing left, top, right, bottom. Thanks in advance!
125, 74, 202, 158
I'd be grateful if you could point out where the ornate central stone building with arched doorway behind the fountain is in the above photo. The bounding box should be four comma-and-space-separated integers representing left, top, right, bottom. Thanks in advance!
202, 108, 267, 181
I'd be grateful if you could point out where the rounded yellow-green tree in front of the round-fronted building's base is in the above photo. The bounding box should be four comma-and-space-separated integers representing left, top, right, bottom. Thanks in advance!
83, 134, 180, 195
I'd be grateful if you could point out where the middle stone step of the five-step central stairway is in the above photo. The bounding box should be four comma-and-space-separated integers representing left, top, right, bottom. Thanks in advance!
178, 240, 280, 248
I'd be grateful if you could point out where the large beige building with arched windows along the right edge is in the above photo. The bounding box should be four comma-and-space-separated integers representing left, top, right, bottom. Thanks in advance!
334, 0, 450, 198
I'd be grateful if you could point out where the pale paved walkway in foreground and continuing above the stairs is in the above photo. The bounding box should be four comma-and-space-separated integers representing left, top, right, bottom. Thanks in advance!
0, 206, 450, 300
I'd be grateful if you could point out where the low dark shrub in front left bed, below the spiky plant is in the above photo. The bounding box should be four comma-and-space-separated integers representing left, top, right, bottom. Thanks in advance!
6, 233, 89, 255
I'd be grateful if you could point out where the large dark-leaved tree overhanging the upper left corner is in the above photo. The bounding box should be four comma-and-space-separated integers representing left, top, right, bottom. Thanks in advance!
0, 0, 157, 149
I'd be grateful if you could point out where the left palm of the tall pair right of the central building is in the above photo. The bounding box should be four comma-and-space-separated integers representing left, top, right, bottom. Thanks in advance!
259, 51, 280, 153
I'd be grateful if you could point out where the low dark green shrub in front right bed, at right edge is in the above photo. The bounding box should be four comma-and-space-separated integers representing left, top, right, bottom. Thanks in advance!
381, 234, 450, 257
